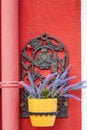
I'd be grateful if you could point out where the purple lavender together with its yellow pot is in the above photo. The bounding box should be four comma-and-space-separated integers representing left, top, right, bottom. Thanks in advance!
21, 65, 87, 127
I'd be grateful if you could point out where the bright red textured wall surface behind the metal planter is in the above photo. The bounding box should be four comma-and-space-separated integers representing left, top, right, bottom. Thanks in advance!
19, 0, 81, 130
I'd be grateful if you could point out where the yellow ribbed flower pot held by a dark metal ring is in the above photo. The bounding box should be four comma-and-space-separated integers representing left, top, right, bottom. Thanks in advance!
28, 98, 57, 127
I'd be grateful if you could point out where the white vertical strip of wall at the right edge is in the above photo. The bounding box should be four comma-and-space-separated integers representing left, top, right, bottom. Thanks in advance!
81, 0, 87, 130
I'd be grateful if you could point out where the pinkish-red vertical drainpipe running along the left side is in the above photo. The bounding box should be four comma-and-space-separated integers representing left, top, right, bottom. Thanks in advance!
1, 0, 19, 130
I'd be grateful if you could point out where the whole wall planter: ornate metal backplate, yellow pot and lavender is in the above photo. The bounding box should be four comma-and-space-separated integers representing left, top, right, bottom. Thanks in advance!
21, 34, 87, 127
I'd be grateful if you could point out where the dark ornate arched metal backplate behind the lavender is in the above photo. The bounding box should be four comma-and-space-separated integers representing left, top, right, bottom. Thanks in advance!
20, 33, 68, 117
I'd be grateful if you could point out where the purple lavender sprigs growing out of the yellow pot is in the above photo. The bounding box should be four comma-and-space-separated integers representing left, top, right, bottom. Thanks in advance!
21, 66, 87, 100
